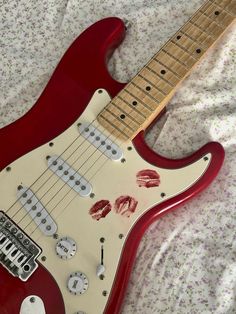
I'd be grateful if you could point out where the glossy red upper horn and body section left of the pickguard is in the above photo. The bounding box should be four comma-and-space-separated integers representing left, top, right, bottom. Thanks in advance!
0, 18, 125, 170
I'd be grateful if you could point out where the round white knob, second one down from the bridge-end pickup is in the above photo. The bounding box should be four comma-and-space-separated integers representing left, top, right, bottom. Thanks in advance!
67, 272, 88, 295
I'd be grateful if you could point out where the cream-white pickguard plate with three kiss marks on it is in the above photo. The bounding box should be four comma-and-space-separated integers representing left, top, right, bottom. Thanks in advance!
0, 91, 211, 314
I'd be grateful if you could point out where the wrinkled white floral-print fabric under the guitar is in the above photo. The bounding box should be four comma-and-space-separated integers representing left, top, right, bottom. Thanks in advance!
0, 0, 236, 314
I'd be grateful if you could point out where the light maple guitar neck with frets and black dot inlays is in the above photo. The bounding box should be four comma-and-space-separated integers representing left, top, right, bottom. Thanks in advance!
98, 0, 236, 141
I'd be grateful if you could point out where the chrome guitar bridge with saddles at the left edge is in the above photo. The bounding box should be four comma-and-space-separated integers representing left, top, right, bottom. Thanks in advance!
0, 211, 42, 281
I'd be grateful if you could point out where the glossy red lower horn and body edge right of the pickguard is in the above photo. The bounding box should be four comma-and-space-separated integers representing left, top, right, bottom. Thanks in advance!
105, 132, 224, 314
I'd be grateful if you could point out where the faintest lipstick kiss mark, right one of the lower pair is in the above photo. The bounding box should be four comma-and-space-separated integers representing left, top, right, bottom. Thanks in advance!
114, 195, 138, 217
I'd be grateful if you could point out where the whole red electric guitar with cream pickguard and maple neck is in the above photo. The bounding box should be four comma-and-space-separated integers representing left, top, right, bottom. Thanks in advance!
0, 0, 236, 314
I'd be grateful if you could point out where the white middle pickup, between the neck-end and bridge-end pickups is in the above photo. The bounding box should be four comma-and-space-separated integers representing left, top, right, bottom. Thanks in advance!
48, 155, 92, 196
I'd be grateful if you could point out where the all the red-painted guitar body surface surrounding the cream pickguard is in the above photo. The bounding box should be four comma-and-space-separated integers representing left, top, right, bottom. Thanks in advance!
0, 18, 224, 314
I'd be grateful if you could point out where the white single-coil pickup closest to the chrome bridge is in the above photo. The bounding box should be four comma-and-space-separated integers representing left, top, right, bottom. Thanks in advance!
18, 186, 57, 236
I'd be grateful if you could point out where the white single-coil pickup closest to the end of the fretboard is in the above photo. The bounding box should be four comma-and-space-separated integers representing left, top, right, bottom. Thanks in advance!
79, 123, 123, 160
